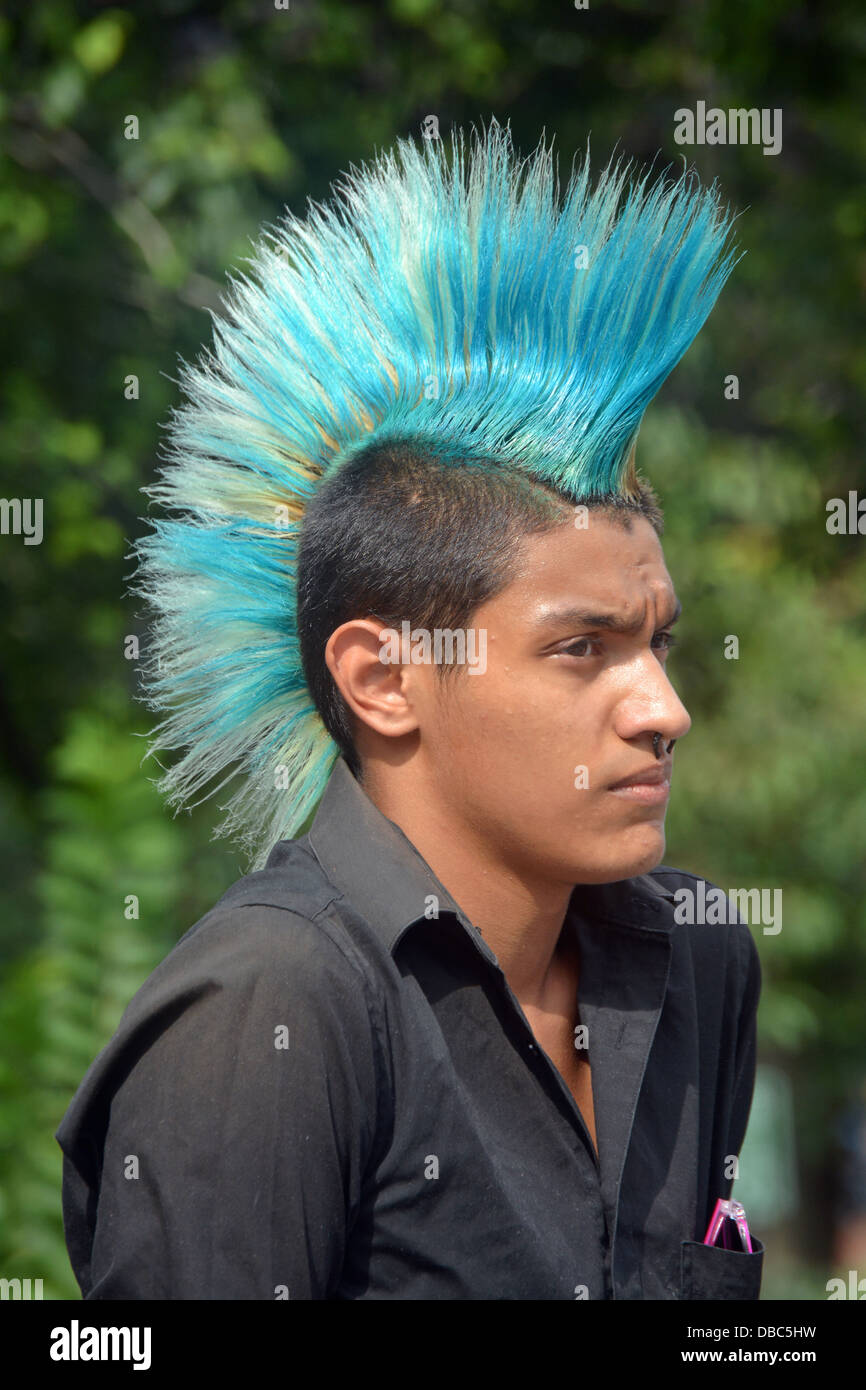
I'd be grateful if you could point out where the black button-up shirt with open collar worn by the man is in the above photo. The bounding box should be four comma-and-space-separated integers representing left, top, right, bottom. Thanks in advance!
57, 759, 763, 1300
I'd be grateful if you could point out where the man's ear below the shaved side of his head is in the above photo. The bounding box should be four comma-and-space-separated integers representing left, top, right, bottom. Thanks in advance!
325, 619, 418, 738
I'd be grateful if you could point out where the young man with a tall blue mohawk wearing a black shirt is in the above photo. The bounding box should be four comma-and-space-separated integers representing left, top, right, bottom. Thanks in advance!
57, 113, 763, 1300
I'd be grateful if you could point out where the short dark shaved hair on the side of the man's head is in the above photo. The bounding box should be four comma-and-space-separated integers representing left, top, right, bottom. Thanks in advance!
297, 436, 663, 777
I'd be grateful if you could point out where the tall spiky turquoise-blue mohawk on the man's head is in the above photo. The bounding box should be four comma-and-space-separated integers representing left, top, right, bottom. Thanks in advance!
135, 120, 735, 867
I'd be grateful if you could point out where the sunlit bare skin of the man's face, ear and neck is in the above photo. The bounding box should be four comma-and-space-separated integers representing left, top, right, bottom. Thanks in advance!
325, 512, 691, 1045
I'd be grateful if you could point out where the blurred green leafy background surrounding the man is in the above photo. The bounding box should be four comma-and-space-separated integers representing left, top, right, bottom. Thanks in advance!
0, 0, 866, 1298
